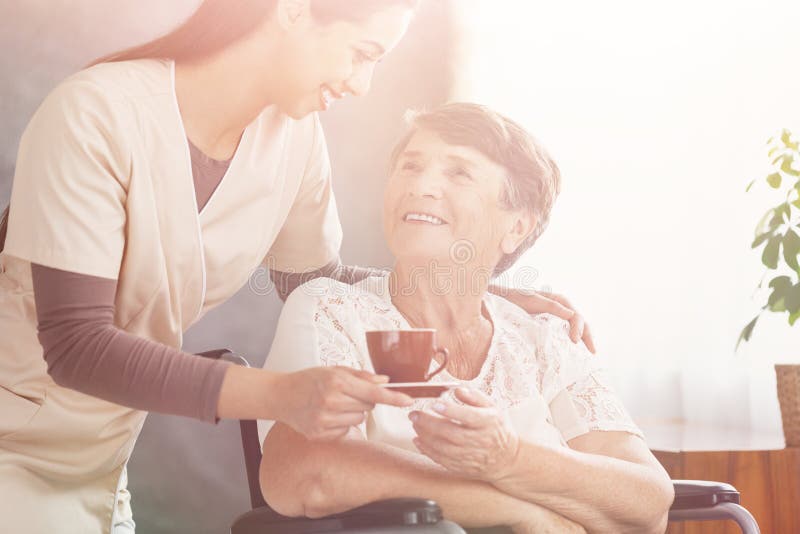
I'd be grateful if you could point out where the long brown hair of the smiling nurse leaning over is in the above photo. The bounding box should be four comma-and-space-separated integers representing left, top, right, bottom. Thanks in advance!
91, 0, 419, 65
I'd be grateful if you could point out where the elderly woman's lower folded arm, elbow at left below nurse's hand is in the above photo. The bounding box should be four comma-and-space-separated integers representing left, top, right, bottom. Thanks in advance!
260, 424, 584, 533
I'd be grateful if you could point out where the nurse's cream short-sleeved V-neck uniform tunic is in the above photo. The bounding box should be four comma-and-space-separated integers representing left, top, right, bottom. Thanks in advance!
0, 56, 341, 533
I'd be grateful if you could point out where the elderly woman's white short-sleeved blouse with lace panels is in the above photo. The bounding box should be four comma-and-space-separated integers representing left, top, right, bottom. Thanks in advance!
258, 276, 642, 451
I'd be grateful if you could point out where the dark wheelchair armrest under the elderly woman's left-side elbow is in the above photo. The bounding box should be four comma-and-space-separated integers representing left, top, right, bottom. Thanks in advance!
231, 498, 442, 534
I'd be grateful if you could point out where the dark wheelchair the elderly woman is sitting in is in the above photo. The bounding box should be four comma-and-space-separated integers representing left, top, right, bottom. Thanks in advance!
198, 349, 760, 534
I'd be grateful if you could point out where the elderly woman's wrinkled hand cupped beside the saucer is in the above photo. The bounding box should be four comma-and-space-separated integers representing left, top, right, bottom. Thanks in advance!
409, 388, 519, 482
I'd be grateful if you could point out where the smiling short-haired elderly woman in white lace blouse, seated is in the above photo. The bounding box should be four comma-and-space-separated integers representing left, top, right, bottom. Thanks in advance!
260, 103, 673, 533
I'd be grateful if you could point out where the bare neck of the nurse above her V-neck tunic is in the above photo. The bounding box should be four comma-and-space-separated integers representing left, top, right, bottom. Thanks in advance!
175, 26, 278, 160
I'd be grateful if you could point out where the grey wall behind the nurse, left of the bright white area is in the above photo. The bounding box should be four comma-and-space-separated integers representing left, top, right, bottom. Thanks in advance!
0, 0, 460, 534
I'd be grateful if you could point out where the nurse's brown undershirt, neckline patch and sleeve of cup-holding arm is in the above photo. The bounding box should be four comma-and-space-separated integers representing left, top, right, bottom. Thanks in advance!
31, 138, 229, 422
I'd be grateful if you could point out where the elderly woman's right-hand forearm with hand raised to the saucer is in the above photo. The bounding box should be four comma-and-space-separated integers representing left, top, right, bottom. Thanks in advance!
409, 384, 674, 533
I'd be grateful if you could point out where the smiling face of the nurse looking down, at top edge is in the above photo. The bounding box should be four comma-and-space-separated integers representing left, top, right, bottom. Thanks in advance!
272, 0, 412, 119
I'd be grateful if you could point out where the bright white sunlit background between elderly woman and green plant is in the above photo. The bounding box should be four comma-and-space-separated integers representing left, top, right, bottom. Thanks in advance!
446, 0, 800, 436
